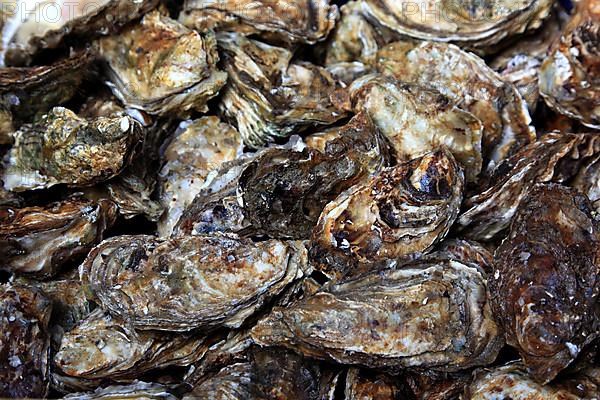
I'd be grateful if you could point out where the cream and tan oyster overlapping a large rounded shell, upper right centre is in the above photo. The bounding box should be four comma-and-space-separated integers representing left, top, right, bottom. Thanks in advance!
337, 74, 482, 182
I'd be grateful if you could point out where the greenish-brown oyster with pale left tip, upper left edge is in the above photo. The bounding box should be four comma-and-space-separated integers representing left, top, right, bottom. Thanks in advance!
2, 107, 142, 192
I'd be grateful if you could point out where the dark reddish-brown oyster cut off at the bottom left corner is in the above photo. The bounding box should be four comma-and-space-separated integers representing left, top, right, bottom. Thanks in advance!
0, 285, 51, 398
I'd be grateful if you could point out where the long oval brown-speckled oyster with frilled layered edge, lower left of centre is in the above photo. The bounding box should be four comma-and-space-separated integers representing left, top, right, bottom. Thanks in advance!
80, 236, 307, 331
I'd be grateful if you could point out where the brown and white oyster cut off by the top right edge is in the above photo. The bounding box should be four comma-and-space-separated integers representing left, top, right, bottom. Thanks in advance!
539, 0, 600, 129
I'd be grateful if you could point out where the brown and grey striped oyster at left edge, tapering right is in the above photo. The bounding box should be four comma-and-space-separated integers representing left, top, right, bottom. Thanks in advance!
0, 198, 117, 277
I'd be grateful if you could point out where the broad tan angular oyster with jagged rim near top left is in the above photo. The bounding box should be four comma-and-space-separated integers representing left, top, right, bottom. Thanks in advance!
99, 11, 227, 117
